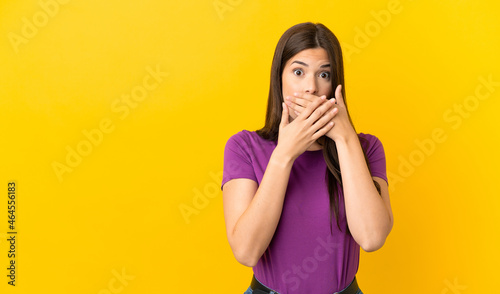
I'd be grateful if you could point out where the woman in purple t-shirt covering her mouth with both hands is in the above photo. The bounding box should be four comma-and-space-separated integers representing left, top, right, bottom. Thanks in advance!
221, 23, 393, 294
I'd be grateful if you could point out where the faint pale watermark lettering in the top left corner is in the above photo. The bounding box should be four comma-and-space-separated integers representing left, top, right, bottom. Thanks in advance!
7, 0, 69, 53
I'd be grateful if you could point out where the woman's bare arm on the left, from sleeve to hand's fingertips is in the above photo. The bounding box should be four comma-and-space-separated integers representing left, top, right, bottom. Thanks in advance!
222, 97, 336, 266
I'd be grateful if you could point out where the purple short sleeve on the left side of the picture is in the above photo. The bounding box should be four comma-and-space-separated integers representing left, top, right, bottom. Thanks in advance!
221, 132, 257, 190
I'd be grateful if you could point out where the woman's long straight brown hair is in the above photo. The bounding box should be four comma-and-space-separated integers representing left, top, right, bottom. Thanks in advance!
256, 22, 380, 232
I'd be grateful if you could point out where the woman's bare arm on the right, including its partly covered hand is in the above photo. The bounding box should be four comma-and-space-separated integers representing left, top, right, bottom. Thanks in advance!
276, 85, 393, 251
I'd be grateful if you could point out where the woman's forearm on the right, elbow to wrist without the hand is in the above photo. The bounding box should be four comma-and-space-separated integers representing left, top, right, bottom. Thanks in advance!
335, 133, 392, 251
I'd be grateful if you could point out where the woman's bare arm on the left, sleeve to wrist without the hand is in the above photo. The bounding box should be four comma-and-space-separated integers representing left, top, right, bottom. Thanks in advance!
222, 149, 293, 266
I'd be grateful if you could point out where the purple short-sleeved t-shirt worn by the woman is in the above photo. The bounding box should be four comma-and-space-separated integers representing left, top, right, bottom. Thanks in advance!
221, 130, 387, 294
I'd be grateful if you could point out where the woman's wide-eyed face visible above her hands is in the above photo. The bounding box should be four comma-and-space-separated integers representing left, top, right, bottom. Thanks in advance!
282, 48, 332, 120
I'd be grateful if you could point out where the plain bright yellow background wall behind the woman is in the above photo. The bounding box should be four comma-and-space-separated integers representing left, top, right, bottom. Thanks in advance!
0, 0, 500, 294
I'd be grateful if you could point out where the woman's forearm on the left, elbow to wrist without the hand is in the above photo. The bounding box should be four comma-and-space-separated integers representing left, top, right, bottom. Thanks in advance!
232, 149, 293, 266
